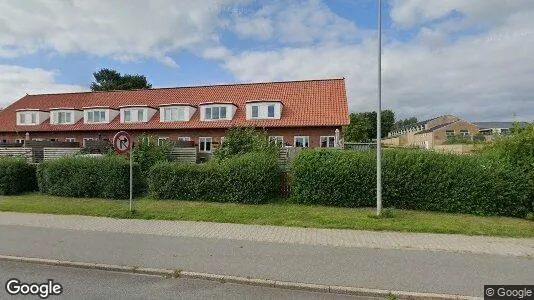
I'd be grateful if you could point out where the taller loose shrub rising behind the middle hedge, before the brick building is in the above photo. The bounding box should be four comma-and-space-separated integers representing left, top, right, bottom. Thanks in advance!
213, 127, 281, 159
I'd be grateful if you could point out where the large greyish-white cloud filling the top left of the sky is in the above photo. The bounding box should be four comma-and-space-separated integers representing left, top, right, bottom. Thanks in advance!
0, 0, 247, 66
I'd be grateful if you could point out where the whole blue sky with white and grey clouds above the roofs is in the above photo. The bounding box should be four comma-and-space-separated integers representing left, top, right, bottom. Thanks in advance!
0, 0, 534, 121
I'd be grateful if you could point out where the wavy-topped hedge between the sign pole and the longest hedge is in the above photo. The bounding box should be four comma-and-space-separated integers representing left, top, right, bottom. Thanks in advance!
149, 153, 280, 203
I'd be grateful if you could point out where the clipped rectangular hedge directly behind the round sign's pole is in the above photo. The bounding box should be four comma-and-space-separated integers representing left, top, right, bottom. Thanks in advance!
37, 156, 142, 199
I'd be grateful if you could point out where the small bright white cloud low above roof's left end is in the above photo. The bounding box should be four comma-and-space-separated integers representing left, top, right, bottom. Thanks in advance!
0, 65, 88, 108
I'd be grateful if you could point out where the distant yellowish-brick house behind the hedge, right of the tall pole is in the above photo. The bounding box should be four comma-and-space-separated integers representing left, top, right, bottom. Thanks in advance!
382, 115, 479, 148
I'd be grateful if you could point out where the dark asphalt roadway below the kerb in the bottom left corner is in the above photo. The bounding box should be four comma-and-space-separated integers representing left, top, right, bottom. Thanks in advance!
0, 261, 378, 300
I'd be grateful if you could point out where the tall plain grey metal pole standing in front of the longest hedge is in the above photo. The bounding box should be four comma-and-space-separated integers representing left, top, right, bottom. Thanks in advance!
376, 0, 382, 216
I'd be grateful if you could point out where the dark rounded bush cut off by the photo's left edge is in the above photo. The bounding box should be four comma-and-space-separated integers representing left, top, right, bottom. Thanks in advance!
0, 157, 37, 195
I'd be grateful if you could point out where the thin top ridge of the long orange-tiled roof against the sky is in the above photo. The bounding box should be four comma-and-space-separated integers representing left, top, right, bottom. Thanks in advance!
23, 77, 345, 98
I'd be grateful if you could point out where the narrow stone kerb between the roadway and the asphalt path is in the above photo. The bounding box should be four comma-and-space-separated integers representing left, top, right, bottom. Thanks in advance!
0, 255, 482, 300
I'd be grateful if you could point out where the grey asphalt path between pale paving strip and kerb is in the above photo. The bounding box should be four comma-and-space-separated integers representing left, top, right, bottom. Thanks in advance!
0, 225, 534, 297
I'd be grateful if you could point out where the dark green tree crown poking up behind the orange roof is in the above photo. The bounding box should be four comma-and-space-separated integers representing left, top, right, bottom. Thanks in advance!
91, 69, 152, 91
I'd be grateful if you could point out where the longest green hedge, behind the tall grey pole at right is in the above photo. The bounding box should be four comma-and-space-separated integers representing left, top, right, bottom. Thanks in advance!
290, 150, 533, 217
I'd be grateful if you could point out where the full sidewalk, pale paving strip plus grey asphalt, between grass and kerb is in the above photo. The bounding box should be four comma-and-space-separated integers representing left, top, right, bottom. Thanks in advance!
0, 213, 534, 297
